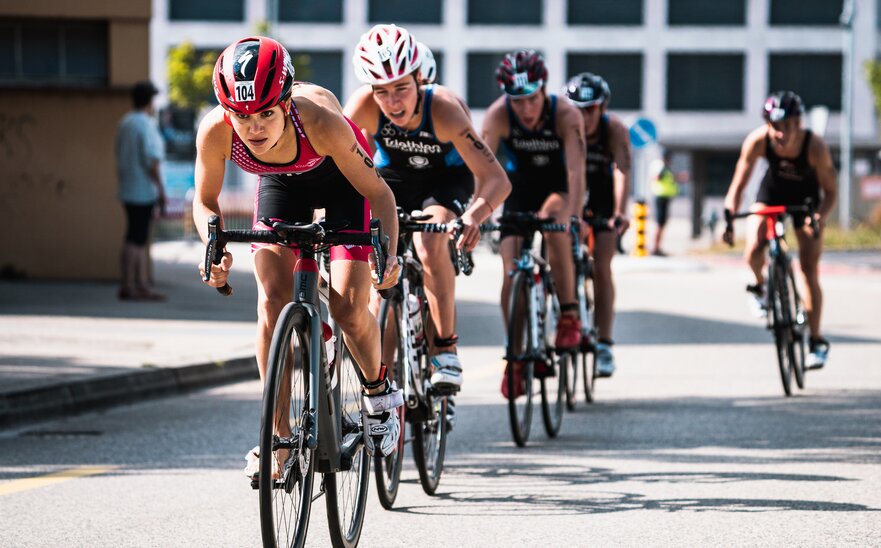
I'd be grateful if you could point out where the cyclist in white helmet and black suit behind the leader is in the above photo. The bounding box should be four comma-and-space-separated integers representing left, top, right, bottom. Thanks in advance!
345, 25, 510, 391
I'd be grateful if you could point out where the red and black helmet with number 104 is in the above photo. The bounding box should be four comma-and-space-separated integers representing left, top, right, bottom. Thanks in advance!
214, 36, 294, 114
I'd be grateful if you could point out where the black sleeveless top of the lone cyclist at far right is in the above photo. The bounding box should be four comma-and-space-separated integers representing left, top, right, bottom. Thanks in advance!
756, 130, 820, 214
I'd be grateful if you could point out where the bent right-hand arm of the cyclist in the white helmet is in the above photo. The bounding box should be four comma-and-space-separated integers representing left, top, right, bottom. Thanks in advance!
431, 93, 511, 225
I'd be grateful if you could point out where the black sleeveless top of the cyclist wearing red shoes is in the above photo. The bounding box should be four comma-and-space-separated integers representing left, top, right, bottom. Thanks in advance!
502, 95, 569, 211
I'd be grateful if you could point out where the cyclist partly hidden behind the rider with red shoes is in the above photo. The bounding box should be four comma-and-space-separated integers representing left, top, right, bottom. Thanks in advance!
564, 72, 631, 377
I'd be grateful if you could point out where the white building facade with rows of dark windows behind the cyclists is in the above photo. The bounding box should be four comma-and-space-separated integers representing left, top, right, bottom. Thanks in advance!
150, 0, 881, 219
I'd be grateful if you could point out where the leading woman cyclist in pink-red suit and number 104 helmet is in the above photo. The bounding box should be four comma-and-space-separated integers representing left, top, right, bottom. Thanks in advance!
193, 36, 403, 462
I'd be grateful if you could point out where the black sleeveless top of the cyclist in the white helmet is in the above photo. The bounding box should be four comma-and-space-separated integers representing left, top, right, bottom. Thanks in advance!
373, 85, 474, 215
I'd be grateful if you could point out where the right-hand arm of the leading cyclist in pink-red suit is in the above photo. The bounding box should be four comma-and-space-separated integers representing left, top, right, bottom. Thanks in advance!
298, 97, 398, 257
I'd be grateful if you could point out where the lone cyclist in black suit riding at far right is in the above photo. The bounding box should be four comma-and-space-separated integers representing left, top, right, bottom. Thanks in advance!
723, 91, 838, 369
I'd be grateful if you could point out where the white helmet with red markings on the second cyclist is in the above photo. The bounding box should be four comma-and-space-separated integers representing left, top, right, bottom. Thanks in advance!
352, 25, 422, 85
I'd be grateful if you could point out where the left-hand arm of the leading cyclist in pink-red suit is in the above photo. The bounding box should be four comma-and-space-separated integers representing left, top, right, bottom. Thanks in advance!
193, 107, 233, 242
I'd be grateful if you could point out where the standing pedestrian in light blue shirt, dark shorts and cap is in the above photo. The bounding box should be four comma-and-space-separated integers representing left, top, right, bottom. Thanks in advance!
116, 82, 165, 301
